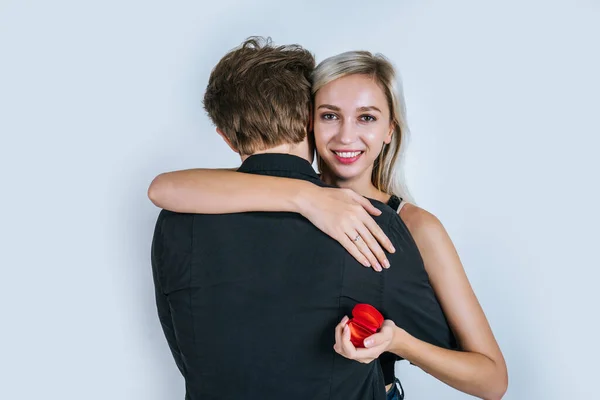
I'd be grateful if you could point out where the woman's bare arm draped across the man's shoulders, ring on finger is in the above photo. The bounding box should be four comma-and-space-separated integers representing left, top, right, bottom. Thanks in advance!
148, 169, 395, 271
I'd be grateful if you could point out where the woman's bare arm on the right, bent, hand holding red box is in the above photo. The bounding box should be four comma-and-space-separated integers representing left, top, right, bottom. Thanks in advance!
336, 206, 508, 400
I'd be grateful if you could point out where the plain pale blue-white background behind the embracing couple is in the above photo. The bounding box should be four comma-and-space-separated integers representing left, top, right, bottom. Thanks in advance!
0, 0, 600, 400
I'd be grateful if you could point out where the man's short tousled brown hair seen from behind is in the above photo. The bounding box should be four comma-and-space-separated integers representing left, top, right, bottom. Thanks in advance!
204, 37, 315, 155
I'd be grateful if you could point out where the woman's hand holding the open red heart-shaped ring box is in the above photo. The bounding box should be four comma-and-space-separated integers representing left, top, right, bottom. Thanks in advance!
333, 317, 400, 364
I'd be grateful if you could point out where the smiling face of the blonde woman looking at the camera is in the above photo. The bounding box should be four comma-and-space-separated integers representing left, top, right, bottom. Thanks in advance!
314, 74, 393, 186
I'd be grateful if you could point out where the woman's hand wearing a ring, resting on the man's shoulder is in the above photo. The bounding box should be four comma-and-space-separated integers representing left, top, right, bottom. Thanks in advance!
297, 186, 396, 271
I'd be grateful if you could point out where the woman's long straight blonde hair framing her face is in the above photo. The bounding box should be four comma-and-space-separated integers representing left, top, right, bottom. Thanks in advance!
312, 51, 412, 201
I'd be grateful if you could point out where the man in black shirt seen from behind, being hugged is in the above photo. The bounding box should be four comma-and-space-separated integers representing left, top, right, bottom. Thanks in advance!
152, 40, 452, 400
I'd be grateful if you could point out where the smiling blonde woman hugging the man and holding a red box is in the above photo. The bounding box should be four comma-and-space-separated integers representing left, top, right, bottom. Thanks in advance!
149, 52, 507, 399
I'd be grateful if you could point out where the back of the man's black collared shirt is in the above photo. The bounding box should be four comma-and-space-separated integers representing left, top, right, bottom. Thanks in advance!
152, 154, 454, 400
